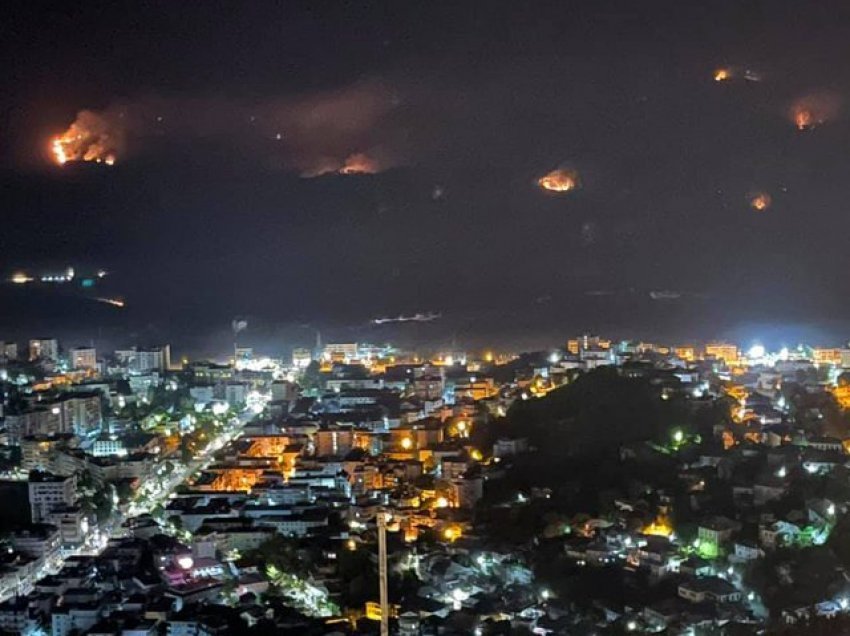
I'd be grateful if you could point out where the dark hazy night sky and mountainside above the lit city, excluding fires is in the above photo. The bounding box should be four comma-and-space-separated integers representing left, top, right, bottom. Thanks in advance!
0, 0, 850, 349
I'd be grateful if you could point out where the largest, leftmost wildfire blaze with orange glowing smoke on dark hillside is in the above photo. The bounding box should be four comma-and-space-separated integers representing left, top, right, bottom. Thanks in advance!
50, 110, 122, 166
